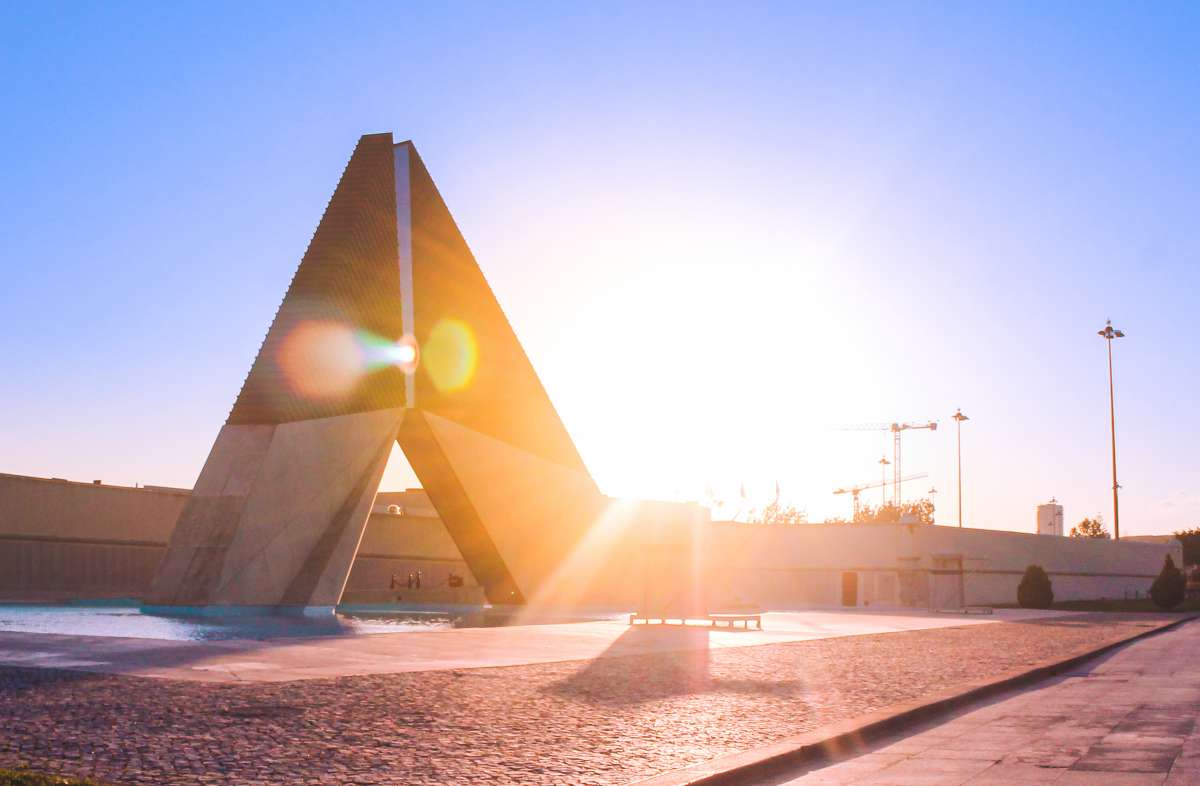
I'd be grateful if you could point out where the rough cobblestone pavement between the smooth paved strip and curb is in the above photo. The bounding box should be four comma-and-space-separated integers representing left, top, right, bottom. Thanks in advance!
0, 614, 1176, 785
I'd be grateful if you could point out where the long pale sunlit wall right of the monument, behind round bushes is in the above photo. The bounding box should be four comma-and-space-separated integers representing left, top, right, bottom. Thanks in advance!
704, 522, 1182, 608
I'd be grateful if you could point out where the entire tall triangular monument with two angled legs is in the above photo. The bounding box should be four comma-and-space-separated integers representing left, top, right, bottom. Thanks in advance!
146, 134, 604, 606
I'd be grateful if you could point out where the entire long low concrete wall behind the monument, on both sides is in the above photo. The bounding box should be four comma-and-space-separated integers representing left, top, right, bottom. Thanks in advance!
0, 474, 1182, 610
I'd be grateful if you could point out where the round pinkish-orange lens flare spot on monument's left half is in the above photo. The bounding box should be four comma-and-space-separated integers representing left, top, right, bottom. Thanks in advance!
278, 320, 366, 398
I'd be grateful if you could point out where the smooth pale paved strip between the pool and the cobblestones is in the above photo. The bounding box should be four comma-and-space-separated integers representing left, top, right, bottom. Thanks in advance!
0, 610, 1061, 682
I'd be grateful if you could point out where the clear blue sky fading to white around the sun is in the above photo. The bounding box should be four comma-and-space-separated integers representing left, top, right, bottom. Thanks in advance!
0, 2, 1200, 534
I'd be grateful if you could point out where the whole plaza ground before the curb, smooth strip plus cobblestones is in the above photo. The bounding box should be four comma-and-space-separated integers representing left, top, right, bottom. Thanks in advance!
0, 612, 1180, 785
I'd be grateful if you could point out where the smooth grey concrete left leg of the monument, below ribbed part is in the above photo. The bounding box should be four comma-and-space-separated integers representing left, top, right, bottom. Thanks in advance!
145, 408, 403, 607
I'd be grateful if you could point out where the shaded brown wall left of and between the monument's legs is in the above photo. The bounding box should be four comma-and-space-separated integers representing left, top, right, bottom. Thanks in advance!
0, 474, 482, 604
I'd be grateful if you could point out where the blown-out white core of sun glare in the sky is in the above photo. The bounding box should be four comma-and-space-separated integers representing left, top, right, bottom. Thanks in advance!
538, 222, 883, 520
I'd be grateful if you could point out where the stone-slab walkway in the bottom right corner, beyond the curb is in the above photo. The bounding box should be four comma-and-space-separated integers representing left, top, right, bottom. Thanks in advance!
770, 622, 1200, 786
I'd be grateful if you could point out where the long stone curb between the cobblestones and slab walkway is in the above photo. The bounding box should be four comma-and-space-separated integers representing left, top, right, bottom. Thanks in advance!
630, 614, 1200, 786
